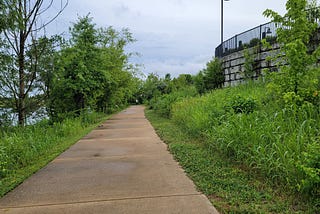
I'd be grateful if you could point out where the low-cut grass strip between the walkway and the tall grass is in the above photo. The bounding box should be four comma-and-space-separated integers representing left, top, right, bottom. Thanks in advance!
146, 110, 316, 213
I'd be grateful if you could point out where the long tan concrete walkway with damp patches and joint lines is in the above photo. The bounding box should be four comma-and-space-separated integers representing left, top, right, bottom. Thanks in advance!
0, 106, 217, 214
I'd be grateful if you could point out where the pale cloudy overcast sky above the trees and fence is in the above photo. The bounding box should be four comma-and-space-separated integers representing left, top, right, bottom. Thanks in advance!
50, 0, 286, 77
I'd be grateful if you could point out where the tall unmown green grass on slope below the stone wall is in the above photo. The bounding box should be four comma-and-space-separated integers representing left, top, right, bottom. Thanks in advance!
171, 83, 320, 200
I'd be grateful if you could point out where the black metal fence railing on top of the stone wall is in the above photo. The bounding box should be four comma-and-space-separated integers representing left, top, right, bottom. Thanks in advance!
215, 22, 277, 58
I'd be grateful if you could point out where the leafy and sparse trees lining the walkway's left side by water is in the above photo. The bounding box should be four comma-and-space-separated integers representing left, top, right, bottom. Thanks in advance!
0, 12, 141, 123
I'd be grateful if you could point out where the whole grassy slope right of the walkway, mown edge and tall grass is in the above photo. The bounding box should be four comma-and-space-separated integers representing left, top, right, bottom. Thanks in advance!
146, 81, 320, 213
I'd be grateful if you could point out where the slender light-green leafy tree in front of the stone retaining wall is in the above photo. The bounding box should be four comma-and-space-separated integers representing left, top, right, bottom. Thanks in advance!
264, 0, 320, 104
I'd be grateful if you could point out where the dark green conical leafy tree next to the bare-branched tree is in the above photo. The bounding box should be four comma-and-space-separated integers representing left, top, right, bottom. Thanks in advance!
50, 16, 107, 117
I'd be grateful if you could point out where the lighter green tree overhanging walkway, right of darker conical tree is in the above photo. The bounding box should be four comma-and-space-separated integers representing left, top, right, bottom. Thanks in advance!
98, 27, 139, 112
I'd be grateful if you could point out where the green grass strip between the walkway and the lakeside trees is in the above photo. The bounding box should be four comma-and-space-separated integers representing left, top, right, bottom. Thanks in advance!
0, 113, 107, 197
